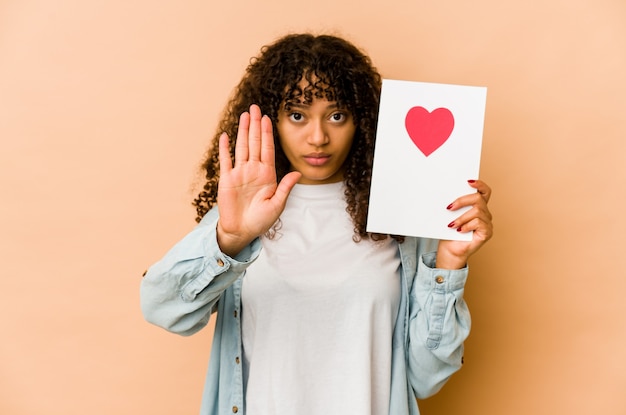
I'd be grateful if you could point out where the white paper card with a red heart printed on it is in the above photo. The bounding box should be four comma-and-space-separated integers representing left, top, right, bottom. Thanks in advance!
367, 79, 487, 241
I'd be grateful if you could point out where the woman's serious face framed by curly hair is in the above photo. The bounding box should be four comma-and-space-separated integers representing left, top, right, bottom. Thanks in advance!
276, 98, 356, 184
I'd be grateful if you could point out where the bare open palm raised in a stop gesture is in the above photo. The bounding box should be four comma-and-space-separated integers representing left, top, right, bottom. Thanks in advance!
217, 105, 301, 257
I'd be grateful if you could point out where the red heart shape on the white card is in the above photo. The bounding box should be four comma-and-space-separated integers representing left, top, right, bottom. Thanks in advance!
404, 107, 454, 157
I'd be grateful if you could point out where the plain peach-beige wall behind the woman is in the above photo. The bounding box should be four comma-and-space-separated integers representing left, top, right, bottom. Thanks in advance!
0, 0, 626, 415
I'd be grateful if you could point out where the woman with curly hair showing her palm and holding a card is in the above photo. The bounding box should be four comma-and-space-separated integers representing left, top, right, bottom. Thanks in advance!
141, 34, 492, 415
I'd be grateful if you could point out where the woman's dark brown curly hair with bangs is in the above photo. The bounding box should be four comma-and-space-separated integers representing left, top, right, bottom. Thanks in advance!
193, 33, 394, 241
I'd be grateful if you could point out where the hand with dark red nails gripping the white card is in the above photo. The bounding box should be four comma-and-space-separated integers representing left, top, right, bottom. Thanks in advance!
436, 180, 493, 269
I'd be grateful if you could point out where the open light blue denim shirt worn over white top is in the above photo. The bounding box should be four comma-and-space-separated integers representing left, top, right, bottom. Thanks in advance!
141, 208, 470, 415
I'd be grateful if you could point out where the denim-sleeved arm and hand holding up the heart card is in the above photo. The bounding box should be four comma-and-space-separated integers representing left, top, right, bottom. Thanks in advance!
408, 180, 493, 398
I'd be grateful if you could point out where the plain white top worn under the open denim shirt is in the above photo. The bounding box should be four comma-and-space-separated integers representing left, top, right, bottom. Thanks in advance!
242, 183, 400, 415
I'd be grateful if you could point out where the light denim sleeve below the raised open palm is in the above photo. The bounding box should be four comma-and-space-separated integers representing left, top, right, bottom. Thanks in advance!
140, 208, 261, 336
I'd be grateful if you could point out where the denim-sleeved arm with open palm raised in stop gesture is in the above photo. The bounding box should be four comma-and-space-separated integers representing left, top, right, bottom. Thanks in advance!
141, 105, 300, 335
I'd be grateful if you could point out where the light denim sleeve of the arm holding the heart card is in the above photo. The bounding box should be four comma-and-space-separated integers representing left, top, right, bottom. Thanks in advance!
408, 252, 471, 399
